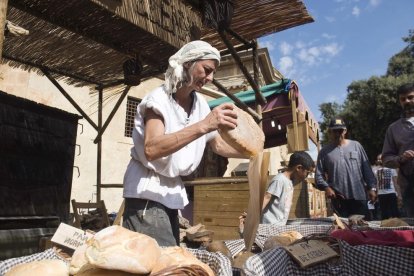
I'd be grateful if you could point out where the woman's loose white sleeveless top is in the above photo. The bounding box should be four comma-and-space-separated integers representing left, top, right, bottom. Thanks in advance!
123, 86, 217, 209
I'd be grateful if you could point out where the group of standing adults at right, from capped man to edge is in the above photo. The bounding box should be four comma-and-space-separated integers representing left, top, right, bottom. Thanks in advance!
315, 83, 414, 219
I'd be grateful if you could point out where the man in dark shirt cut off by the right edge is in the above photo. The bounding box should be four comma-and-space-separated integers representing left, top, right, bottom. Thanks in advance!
382, 83, 414, 217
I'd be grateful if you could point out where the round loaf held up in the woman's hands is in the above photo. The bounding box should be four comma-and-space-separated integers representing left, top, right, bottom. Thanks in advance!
219, 107, 265, 157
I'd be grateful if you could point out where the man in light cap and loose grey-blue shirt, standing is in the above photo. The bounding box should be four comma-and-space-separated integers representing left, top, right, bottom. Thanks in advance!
315, 118, 376, 218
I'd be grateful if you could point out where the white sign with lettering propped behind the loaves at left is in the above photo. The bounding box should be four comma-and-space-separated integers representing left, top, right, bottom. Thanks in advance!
52, 223, 93, 250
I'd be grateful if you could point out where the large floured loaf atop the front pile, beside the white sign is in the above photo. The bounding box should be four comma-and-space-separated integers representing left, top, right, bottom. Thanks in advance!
85, 225, 161, 274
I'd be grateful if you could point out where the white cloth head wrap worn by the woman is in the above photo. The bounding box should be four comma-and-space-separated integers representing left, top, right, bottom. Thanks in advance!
165, 40, 220, 95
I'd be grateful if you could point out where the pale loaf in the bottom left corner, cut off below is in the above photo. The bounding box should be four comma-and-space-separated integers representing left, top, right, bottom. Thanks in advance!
5, 260, 69, 276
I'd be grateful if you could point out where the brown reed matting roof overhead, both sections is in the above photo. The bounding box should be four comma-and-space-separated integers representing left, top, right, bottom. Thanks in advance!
3, 0, 313, 89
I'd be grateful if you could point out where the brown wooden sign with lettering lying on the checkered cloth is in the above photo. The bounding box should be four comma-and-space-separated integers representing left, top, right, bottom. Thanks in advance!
285, 240, 338, 268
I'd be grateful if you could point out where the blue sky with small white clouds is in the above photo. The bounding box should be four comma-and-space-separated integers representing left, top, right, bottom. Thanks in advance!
259, 0, 414, 121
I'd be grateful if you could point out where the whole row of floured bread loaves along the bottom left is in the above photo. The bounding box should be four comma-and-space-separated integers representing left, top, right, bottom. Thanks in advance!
6, 226, 214, 276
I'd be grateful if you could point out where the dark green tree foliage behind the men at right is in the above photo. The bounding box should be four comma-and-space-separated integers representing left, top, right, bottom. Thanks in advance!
319, 30, 414, 161
